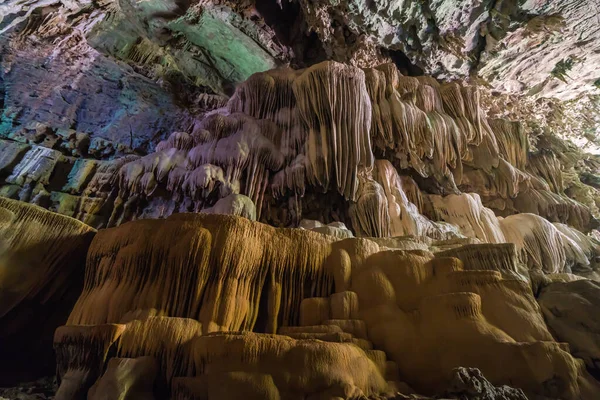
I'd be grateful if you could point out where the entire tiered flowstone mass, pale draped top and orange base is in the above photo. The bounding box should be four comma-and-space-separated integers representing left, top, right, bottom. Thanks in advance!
0, 54, 600, 400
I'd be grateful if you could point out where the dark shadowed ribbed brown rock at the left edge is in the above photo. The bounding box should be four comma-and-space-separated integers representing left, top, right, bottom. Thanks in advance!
0, 197, 94, 386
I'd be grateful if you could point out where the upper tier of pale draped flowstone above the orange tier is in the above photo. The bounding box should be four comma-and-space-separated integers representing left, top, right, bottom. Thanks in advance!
0, 62, 598, 276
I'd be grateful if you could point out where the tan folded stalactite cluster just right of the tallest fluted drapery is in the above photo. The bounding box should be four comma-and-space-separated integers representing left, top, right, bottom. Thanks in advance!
366, 65, 497, 190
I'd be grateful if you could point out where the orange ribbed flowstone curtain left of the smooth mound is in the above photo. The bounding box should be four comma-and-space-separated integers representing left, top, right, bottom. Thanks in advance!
69, 214, 333, 332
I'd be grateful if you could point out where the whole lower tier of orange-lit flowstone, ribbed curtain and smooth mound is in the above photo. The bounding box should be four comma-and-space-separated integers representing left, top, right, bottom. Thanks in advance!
45, 214, 600, 399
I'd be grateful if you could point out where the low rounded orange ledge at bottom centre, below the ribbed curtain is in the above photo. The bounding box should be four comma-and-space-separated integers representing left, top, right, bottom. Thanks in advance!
174, 333, 387, 399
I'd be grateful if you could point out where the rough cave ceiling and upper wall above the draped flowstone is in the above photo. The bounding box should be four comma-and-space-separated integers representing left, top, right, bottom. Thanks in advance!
0, 0, 600, 152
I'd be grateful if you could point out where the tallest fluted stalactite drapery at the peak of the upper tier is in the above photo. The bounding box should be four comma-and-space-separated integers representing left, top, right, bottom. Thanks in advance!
293, 62, 373, 200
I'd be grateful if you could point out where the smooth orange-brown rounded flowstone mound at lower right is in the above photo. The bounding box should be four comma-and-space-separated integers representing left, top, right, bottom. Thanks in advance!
342, 251, 598, 399
